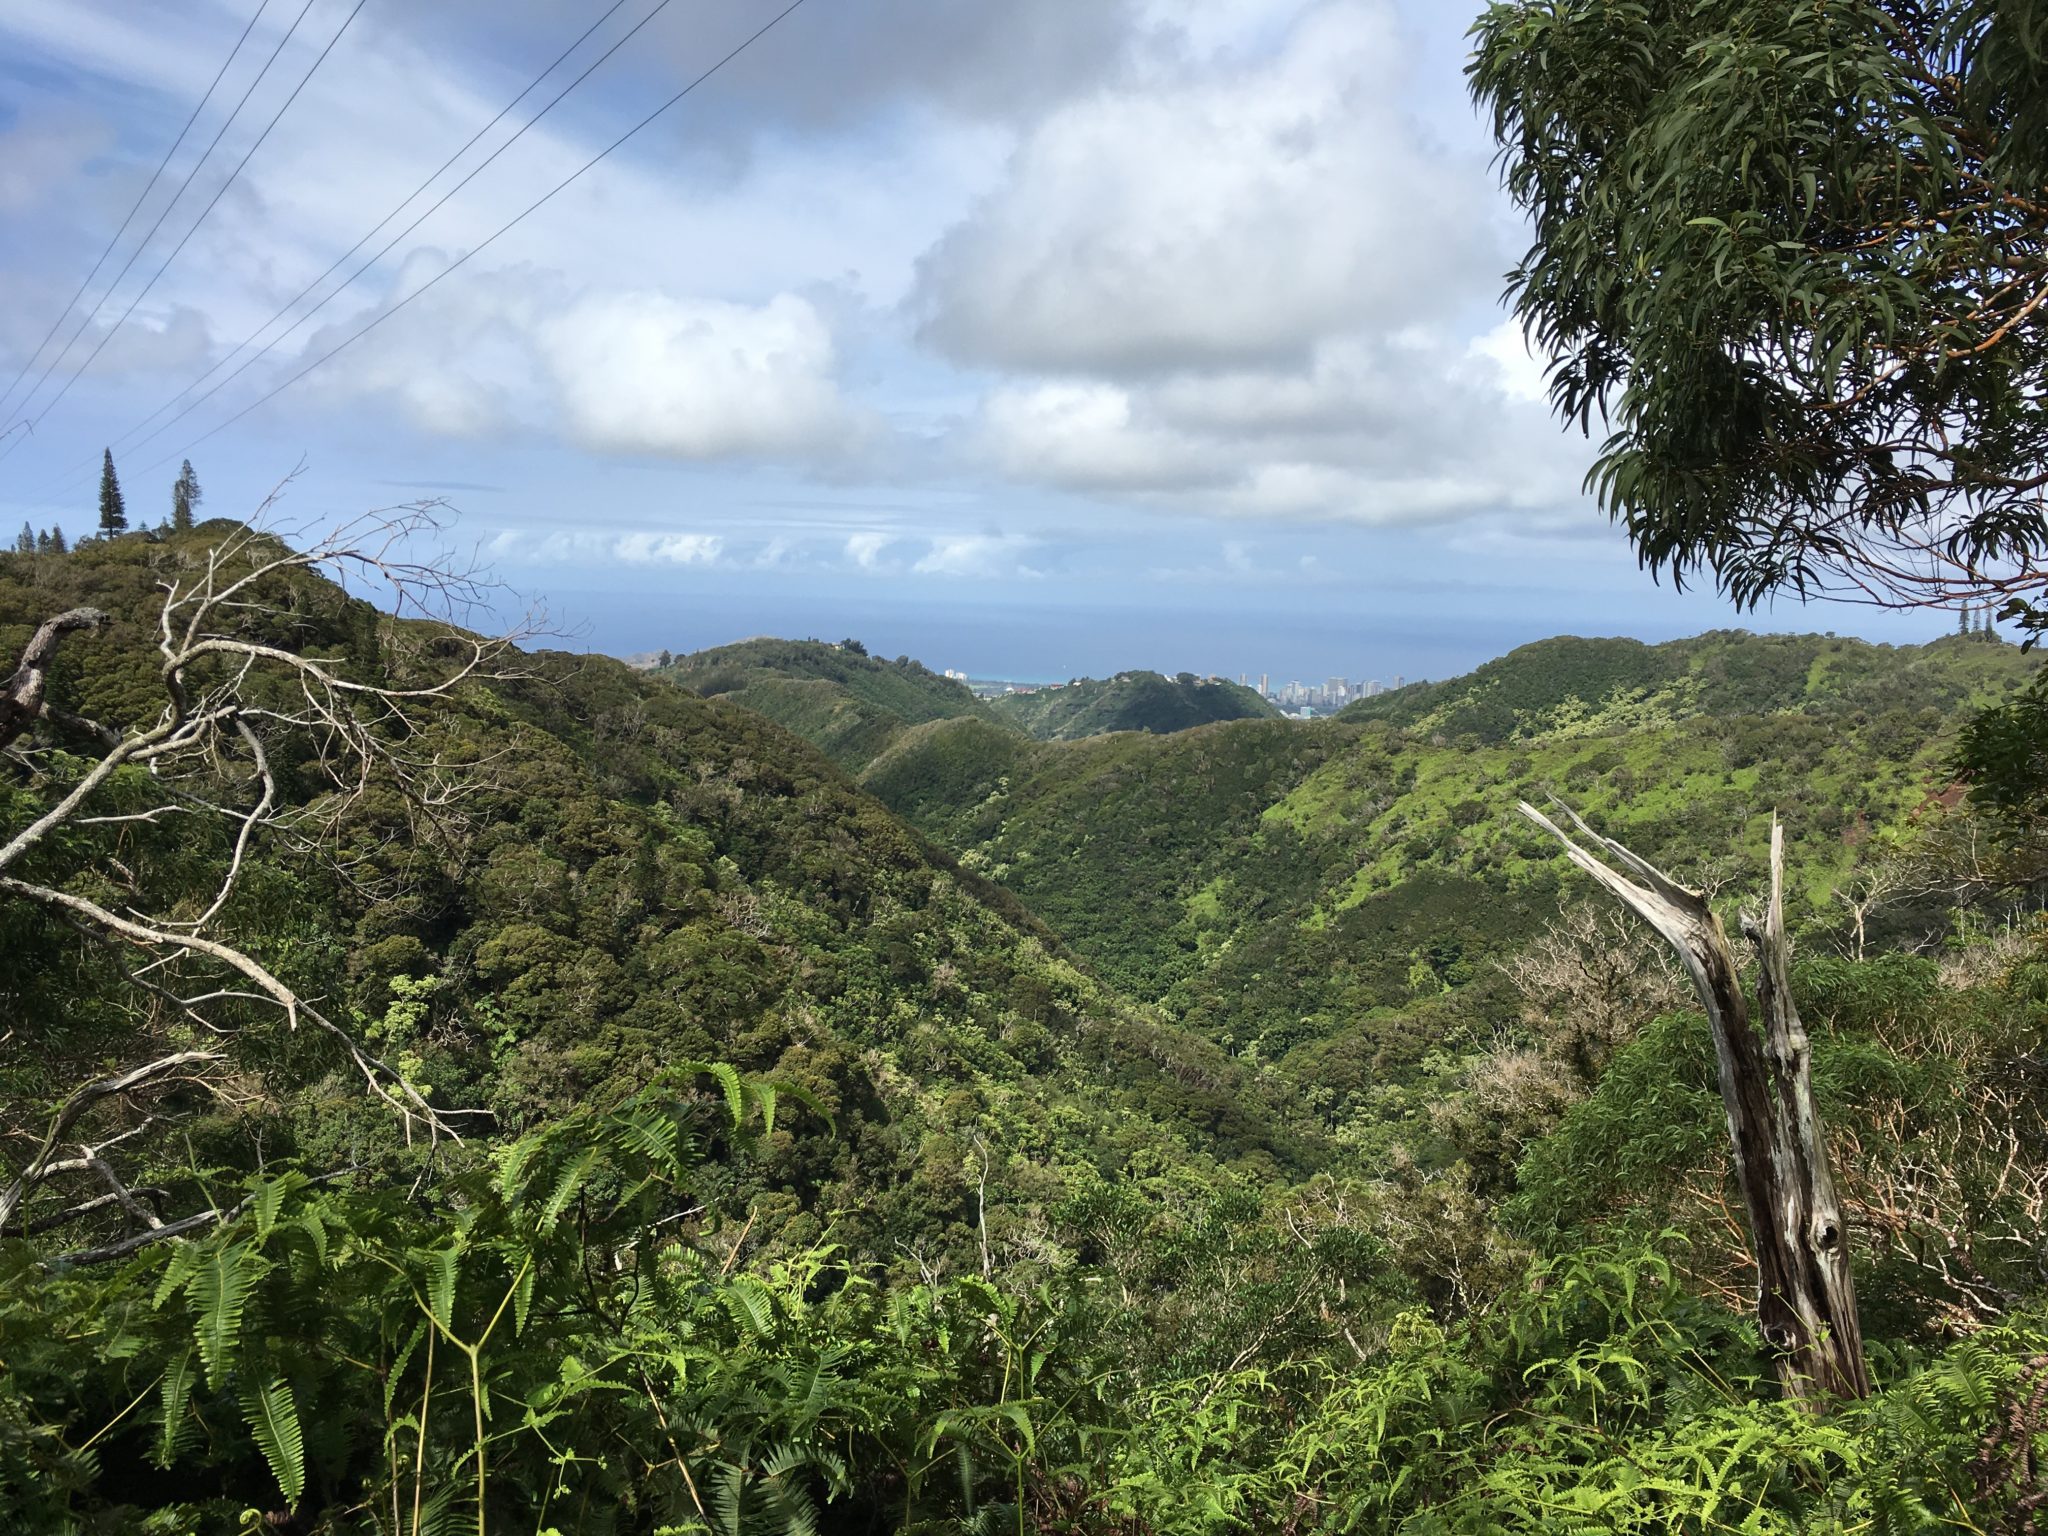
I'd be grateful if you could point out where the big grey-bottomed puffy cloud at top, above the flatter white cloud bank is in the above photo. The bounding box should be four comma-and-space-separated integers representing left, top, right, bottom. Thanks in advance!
915, 0, 1497, 373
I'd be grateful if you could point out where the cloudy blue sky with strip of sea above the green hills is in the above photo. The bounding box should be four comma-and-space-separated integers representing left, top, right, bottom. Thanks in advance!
0, 0, 1952, 684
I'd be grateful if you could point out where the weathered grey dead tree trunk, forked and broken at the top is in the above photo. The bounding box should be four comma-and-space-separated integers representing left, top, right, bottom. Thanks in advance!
1522, 801, 1870, 1397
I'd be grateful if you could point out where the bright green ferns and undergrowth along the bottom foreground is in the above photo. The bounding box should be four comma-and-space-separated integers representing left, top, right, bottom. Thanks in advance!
16, 975, 2048, 1536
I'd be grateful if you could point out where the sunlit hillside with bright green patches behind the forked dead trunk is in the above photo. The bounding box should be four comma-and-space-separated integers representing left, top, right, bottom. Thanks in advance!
868, 631, 2036, 1139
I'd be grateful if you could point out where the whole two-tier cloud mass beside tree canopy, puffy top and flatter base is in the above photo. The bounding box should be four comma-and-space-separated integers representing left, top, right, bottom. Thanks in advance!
915, 0, 1583, 524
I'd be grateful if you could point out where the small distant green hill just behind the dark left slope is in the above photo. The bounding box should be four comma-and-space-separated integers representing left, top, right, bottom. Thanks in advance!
655, 639, 991, 772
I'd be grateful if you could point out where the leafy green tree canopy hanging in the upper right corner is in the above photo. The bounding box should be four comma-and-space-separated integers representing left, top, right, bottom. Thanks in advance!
1470, 0, 2048, 618
